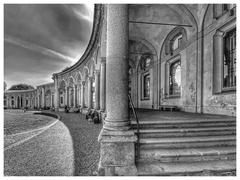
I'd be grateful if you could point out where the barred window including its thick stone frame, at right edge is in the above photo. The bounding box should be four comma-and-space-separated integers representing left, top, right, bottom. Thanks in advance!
212, 21, 236, 94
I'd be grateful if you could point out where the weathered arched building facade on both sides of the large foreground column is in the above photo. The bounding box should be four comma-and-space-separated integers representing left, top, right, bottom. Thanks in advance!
4, 4, 236, 116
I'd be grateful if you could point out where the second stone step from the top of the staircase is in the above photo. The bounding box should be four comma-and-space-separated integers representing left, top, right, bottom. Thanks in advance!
134, 126, 236, 138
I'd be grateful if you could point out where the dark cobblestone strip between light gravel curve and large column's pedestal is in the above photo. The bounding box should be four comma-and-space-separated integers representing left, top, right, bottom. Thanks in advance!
48, 112, 102, 176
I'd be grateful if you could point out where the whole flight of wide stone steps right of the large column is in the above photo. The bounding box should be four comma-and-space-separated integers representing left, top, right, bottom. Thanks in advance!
131, 112, 236, 176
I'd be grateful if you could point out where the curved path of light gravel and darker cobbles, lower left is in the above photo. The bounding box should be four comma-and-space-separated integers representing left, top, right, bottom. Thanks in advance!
4, 113, 101, 176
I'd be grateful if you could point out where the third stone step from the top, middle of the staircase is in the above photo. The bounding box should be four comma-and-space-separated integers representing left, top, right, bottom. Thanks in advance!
139, 135, 236, 149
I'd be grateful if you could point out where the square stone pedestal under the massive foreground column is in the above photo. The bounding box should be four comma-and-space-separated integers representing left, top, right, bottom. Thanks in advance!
98, 129, 137, 176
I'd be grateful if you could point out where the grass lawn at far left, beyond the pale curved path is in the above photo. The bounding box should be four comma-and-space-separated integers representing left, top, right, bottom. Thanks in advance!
4, 111, 55, 135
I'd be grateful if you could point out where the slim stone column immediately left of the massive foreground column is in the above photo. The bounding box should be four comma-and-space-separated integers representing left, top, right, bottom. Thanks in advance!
100, 58, 106, 111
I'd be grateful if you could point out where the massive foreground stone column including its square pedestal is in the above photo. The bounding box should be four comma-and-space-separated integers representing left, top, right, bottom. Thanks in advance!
98, 4, 137, 175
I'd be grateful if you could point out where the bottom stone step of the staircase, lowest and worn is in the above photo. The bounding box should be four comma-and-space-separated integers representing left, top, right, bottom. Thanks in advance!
137, 160, 236, 176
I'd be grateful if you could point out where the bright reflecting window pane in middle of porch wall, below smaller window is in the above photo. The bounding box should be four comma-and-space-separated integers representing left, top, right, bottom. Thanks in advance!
169, 61, 181, 95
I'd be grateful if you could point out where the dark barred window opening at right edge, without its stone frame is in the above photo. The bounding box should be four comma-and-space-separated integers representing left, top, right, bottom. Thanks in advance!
223, 29, 236, 88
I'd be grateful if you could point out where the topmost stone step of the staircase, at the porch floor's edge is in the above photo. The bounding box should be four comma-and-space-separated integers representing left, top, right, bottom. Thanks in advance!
131, 120, 236, 129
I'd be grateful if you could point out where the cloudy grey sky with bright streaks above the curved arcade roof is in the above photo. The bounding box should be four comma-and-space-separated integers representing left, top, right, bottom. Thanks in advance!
4, 4, 93, 88
